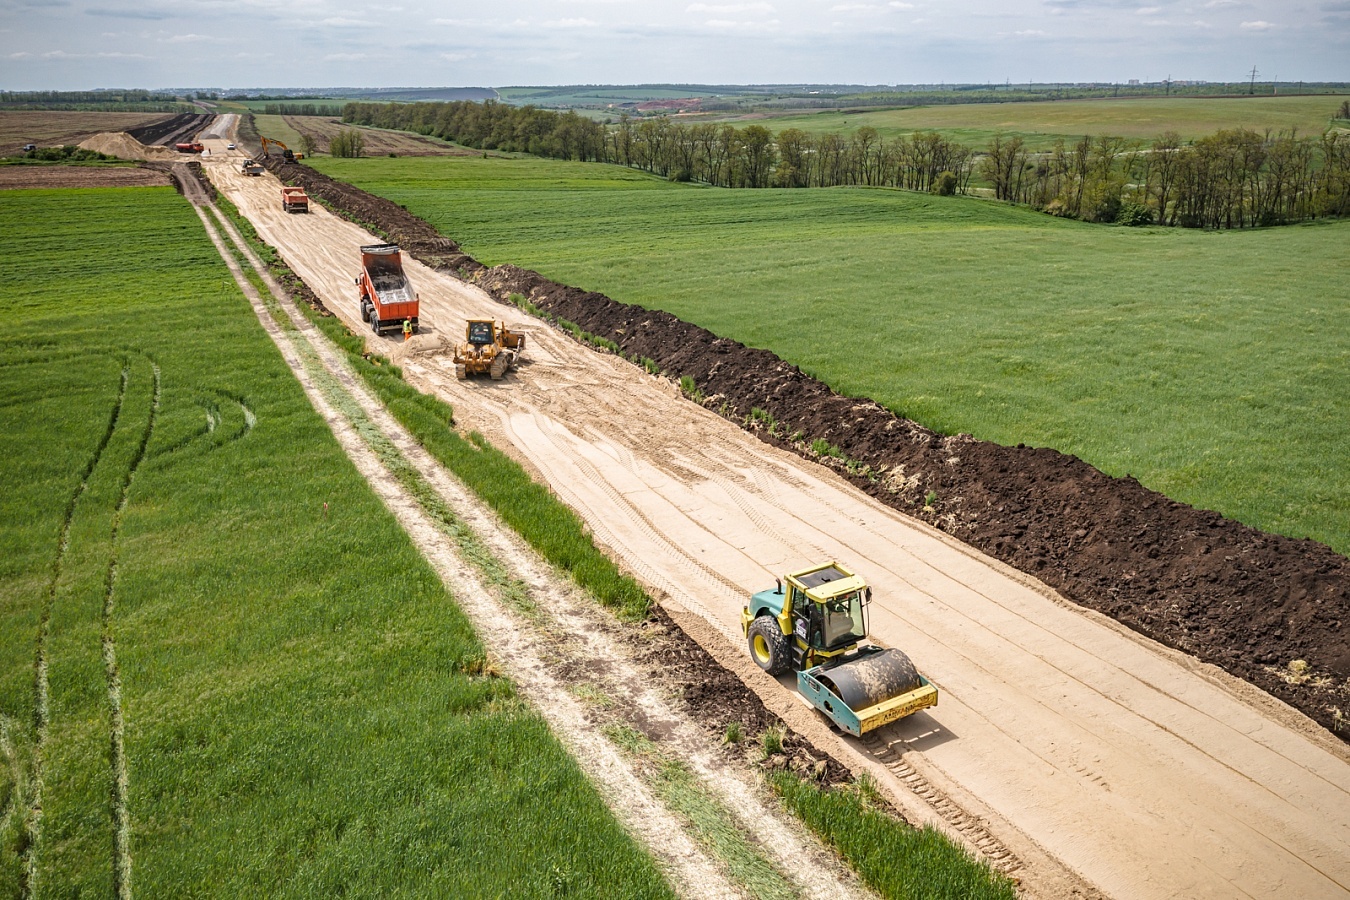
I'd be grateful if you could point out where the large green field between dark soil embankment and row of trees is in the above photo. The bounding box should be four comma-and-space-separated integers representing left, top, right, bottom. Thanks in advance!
306, 159, 1350, 553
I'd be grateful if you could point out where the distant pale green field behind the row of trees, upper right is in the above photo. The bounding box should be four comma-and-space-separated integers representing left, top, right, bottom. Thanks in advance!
707, 94, 1345, 150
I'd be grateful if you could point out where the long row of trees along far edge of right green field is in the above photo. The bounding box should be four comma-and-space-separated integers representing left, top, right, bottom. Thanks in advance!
343, 100, 1350, 228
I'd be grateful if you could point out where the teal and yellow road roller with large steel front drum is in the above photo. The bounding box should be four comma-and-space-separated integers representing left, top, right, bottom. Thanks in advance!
741, 560, 937, 737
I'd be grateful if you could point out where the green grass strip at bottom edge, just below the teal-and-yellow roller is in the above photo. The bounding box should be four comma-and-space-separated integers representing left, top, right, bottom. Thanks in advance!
770, 772, 1017, 900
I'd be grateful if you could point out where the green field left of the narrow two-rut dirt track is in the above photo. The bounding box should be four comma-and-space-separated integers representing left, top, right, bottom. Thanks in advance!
0, 188, 668, 897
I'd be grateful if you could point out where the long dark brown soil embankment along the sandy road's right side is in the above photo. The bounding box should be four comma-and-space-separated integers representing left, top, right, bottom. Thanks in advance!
273, 163, 1350, 739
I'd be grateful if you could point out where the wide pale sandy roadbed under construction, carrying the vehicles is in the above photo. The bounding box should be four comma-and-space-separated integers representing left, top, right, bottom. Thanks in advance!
204, 128, 1350, 897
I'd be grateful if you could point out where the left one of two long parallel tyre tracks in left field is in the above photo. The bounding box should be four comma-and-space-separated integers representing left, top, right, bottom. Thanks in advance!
20, 362, 131, 900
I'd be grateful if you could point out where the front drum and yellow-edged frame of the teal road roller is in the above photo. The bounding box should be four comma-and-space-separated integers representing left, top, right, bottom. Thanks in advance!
797, 650, 937, 737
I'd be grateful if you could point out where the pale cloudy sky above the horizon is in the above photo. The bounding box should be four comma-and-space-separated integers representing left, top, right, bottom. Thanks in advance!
0, 0, 1350, 90
